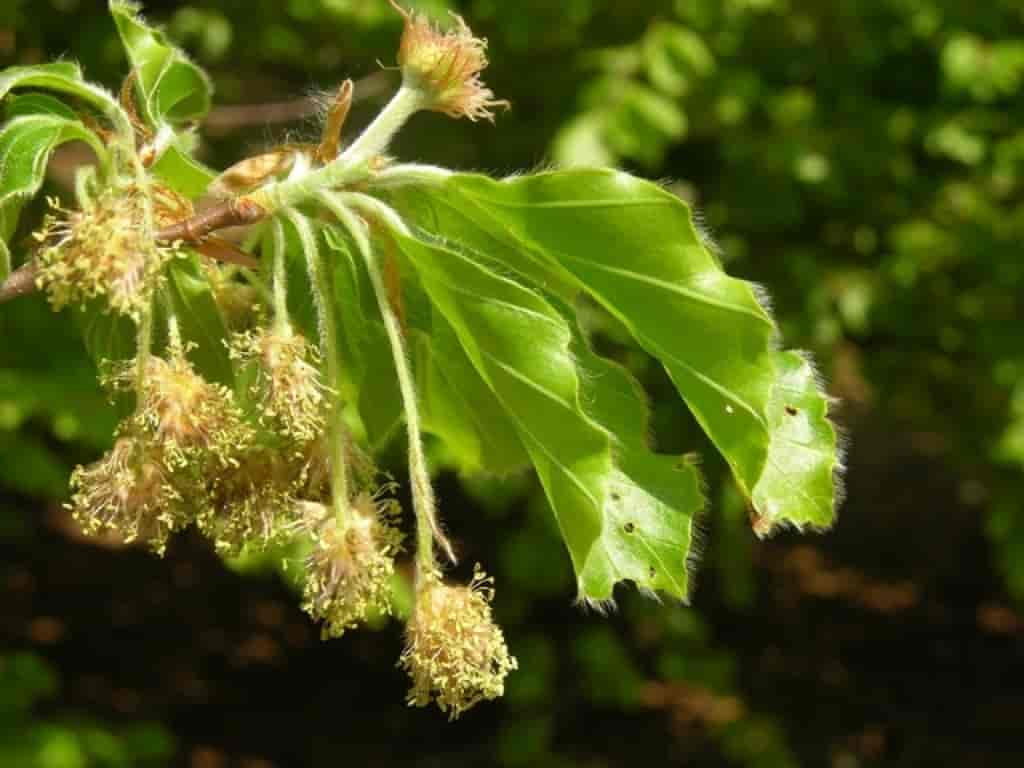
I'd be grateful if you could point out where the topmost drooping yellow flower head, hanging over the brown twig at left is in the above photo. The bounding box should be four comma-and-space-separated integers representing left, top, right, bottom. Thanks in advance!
35, 186, 175, 319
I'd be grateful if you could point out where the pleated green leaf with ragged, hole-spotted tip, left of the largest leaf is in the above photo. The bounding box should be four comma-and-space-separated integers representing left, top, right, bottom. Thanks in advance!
387, 234, 699, 601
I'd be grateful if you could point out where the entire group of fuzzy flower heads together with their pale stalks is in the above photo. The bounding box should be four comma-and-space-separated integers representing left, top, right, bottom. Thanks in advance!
41, 0, 517, 720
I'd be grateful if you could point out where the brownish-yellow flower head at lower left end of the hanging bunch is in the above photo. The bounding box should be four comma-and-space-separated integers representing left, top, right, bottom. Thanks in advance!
68, 436, 189, 554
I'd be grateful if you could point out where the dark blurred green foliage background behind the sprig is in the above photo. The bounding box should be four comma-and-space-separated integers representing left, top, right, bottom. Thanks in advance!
0, 0, 1024, 768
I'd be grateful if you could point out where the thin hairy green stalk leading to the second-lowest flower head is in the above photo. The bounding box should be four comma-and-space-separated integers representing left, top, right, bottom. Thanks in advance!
284, 210, 349, 531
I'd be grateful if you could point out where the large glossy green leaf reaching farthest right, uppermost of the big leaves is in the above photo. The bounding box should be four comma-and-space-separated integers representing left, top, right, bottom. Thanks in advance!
391, 170, 841, 534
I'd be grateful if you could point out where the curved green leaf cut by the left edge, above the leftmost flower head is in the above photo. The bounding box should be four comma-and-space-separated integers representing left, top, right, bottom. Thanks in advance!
0, 114, 106, 280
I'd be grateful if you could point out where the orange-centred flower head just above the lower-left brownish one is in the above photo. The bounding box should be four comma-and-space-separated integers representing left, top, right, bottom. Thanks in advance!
105, 349, 252, 468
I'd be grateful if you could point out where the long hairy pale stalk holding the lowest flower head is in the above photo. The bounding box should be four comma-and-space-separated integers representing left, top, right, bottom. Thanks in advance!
319, 193, 456, 575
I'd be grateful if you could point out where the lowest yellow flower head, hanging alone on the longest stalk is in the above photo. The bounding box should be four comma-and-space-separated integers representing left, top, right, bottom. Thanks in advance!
398, 566, 517, 720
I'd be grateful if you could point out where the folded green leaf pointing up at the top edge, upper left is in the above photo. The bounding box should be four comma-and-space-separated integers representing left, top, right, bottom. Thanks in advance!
111, 0, 213, 128
